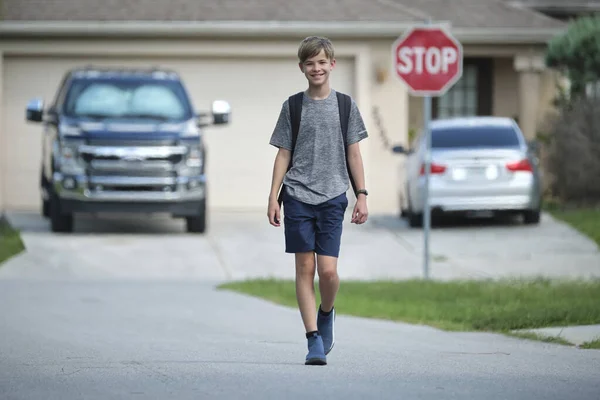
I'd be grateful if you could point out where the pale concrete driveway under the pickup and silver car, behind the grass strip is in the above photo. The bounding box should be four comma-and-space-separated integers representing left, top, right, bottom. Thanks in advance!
0, 212, 600, 281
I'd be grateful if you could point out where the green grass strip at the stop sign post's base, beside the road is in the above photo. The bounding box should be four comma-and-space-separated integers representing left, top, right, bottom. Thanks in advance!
220, 279, 600, 333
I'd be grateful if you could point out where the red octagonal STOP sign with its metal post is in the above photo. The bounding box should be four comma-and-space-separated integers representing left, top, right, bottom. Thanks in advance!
392, 19, 463, 279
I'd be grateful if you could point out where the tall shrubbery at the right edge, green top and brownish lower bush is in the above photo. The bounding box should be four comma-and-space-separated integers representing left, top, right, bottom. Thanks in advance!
545, 15, 600, 205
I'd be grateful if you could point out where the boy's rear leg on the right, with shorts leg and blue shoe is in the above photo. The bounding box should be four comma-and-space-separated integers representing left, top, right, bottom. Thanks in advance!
316, 193, 348, 354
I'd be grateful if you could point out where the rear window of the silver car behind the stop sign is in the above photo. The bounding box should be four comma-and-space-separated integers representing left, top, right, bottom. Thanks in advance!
431, 126, 520, 149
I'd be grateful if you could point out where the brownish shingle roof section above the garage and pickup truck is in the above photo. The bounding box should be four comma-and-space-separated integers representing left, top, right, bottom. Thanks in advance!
1, 0, 422, 22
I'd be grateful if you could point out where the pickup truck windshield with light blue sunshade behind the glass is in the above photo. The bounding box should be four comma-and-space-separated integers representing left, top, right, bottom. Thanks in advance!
64, 79, 193, 120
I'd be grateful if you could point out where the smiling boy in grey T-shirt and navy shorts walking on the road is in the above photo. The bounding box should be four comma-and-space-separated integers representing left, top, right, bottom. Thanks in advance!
267, 36, 368, 365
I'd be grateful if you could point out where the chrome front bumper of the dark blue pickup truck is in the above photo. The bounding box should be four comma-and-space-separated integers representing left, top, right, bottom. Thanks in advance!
53, 172, 206, 216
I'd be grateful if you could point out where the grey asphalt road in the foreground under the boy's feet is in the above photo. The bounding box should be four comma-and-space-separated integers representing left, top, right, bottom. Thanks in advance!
0, 280, 600, 400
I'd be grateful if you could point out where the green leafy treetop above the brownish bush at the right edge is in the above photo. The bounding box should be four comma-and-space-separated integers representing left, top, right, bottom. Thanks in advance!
546, 15, 600, 94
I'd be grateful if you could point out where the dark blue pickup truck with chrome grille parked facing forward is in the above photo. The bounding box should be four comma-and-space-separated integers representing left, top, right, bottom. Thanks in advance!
26, 67, 231, 233
